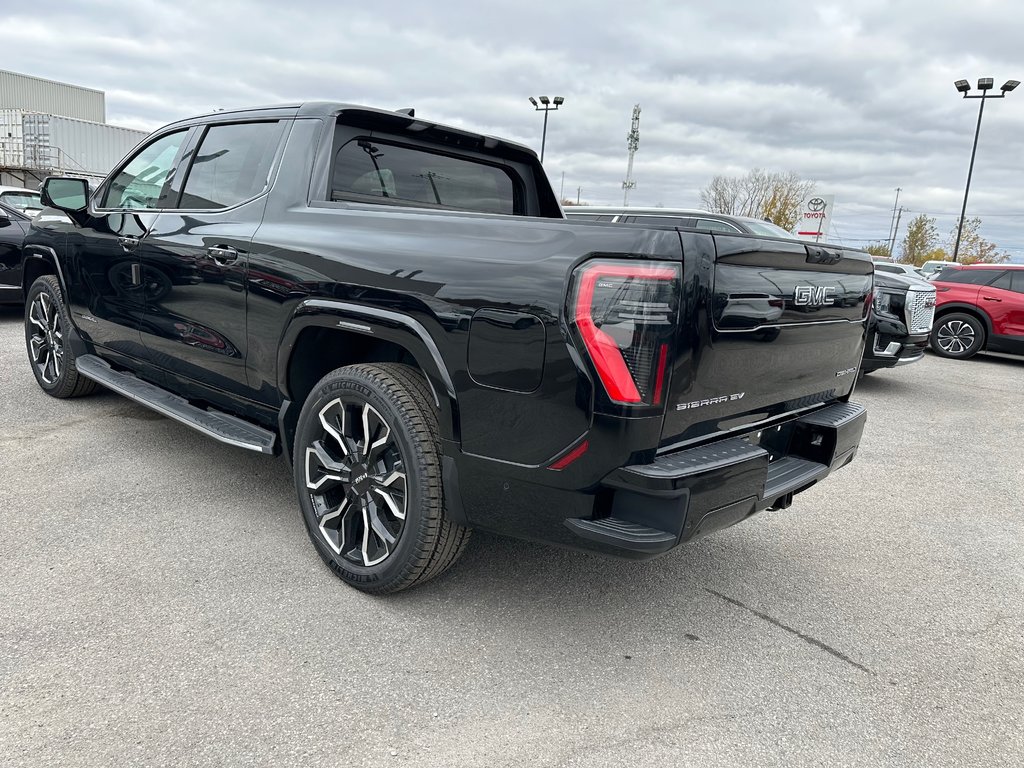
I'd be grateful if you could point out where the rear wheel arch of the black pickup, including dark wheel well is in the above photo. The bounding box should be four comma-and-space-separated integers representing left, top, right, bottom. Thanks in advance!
278, 299, 460, 457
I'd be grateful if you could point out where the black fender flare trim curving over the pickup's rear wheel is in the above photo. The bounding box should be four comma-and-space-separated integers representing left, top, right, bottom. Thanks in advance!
278, 299, 460, 442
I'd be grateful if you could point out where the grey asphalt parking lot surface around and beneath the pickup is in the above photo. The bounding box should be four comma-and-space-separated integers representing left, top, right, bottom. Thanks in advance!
0, 308, 1024, 767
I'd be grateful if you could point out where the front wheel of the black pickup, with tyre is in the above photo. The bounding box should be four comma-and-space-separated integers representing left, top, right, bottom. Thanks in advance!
25, 274, 96, 397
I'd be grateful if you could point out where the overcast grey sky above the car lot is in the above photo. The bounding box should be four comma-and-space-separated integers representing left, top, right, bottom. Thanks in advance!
0, 0, 1024, 260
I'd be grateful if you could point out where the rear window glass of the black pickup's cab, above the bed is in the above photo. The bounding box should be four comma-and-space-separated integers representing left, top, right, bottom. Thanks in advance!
331, 138, 522, 214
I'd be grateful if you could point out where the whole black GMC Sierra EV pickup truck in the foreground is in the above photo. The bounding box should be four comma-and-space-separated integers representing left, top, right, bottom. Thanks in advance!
24, 102, 872, 593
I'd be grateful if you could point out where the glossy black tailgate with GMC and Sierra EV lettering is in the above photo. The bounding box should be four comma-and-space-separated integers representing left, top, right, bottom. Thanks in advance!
662, 234, 872, 446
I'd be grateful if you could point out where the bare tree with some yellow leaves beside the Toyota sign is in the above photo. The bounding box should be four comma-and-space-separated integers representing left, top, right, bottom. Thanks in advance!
700, 168, 814, 229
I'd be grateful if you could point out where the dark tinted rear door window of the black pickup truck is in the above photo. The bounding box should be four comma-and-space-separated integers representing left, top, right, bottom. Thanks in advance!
177, 122, 283, 210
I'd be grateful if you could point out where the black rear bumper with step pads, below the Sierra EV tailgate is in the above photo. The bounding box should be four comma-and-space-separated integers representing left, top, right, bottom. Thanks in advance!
564, 402, 866, 558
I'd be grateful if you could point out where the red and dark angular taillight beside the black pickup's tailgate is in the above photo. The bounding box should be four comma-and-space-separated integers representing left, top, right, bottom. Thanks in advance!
570, 262, 679, 406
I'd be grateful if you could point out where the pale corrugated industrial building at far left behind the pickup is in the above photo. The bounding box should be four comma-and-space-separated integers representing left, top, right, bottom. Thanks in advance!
0, 70, 146, 188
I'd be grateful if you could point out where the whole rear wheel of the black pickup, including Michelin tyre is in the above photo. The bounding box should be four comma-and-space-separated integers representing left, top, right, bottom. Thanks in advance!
294, 364, 469, 594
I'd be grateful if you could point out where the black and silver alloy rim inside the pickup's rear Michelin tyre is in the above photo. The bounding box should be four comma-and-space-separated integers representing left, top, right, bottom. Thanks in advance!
305, 396, 407, 567
